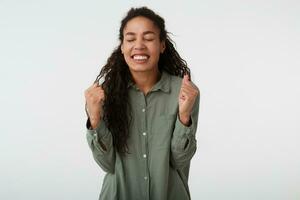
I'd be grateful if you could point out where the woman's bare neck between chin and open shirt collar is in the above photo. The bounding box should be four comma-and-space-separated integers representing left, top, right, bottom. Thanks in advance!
131, 68, 161, 95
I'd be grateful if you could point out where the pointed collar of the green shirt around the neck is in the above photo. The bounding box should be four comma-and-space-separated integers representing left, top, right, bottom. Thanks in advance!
128, 70, 170, 93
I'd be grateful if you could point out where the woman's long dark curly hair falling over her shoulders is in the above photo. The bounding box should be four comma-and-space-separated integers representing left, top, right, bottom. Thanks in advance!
95, 7, 190, 155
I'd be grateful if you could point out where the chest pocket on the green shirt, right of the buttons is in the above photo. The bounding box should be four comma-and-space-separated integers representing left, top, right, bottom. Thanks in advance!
151, 114, 177, 149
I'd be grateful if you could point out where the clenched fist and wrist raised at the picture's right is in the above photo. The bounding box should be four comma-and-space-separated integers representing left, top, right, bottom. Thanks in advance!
178, 74, 199, 125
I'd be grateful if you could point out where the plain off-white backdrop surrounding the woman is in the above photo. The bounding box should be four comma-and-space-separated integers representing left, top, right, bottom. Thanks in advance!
0, 0, 300, 200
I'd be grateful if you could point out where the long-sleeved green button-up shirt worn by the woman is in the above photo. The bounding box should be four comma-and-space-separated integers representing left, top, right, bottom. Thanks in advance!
86, 71, 200, 200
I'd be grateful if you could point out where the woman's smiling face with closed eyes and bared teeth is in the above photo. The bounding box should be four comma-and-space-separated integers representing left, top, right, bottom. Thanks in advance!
121, 17, 165, 72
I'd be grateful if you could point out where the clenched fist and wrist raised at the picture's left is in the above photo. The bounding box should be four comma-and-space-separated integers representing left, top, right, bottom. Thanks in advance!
84, 82, 105, 129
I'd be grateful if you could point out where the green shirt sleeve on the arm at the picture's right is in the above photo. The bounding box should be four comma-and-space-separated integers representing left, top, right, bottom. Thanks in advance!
171, 93, 200, 169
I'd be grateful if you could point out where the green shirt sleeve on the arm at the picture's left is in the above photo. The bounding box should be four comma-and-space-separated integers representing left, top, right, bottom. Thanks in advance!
86, 119, 116, 173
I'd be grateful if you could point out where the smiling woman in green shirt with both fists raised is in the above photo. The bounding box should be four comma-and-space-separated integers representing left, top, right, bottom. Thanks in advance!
85, 7, 200, 200
